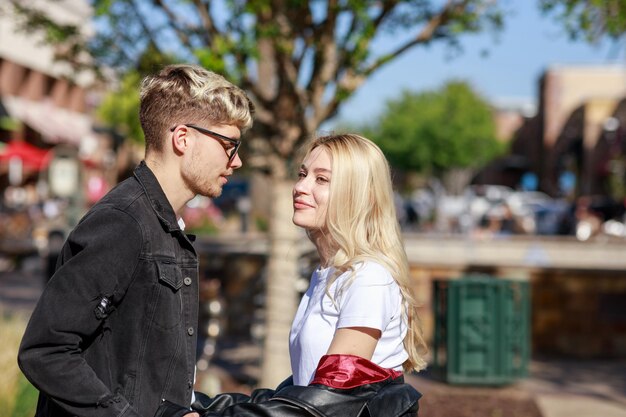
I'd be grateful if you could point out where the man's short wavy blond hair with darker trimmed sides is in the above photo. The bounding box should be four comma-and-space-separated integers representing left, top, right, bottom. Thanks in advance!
139, 64, 254, 152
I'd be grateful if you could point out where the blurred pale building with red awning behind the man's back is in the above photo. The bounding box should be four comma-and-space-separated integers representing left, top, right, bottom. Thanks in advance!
0, 0, 120, 249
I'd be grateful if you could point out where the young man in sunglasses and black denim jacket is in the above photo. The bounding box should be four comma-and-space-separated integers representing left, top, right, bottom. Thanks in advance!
18, 65, 253, 417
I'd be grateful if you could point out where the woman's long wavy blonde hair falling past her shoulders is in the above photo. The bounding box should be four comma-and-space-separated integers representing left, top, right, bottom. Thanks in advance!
305, 134, 426, 371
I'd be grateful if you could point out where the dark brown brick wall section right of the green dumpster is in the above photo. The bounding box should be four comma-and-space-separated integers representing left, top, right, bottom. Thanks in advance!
531, 271, 626, 358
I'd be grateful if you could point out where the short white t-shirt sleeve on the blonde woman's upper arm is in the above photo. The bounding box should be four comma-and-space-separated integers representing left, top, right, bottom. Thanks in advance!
337, 262, 401, 331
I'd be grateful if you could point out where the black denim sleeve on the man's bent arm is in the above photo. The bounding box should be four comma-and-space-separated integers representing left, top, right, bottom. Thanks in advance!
18, 207, 142, 417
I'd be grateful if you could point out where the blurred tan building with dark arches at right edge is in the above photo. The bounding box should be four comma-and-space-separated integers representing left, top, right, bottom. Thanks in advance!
475, 65, 626, 197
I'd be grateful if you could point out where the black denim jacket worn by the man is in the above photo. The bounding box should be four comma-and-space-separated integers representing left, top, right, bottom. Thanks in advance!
18, 162, 198, 417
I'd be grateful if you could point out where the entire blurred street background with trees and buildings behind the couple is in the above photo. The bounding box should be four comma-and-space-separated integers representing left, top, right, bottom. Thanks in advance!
0, 0, 626, 417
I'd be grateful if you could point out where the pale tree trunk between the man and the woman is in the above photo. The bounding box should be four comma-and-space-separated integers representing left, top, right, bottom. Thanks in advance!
260, 167, 300, 388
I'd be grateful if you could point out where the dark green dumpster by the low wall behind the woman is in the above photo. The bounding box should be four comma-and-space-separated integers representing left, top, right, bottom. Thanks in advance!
433, 276, 530, 385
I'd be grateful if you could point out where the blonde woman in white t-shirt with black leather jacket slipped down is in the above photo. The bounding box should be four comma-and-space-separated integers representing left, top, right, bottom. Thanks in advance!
155, 135, 425, 417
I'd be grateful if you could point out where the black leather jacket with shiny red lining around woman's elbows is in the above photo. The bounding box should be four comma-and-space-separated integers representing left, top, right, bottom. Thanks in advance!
155, 355, 421, 417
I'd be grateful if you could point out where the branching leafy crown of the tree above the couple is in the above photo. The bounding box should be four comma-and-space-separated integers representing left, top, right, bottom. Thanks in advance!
9, 0, 502, 159
